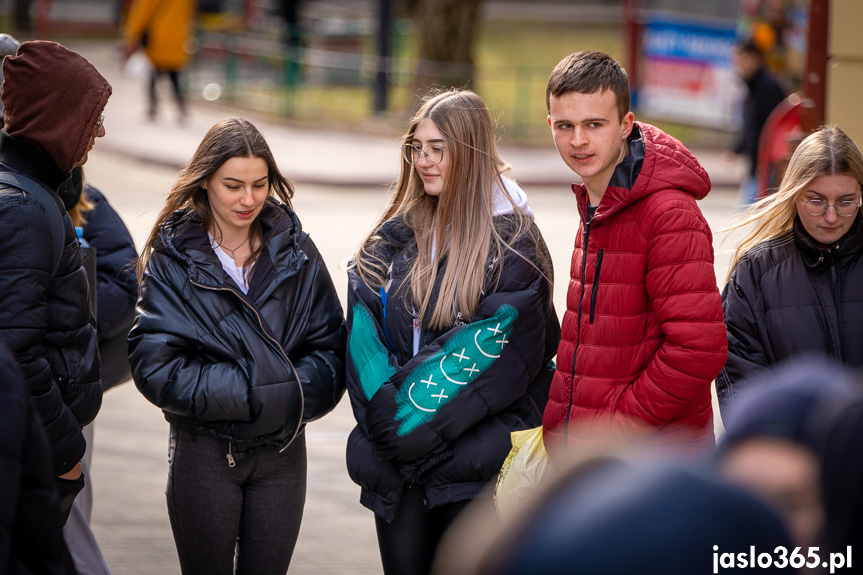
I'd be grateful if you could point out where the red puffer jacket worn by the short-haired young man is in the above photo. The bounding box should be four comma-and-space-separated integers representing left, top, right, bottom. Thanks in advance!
543, 123, 728, 452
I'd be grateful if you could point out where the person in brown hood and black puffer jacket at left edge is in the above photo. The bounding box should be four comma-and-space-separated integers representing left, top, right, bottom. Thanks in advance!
0, 41, 111, 515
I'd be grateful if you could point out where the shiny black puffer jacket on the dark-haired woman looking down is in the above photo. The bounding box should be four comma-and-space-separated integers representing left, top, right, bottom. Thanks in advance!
129, 201, 345, 452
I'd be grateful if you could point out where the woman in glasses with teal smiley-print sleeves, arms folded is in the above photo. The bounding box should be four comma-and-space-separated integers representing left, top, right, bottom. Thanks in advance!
347, 89, 560, 575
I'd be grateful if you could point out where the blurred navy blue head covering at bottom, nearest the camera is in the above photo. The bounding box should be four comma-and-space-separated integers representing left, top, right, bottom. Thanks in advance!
437, 458, 790, 575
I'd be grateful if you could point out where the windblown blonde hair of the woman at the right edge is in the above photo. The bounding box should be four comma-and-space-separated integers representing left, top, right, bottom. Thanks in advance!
722, 125, 863, 281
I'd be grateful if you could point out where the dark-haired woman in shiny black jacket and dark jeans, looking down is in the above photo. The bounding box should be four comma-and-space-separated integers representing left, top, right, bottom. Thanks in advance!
129, 118, 345, 575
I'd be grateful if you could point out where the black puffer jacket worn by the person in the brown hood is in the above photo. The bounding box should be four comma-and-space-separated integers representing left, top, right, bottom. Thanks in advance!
0, 132, 102, 475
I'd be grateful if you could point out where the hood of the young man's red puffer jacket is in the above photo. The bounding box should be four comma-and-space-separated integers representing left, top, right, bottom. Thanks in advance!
572, 122, 711, 218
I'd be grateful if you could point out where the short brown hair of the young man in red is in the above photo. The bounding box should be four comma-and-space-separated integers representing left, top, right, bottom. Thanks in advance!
545, 51, 629, 120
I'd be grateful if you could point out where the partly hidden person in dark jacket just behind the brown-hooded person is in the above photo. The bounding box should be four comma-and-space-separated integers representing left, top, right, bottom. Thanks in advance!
59, 166, 138, 575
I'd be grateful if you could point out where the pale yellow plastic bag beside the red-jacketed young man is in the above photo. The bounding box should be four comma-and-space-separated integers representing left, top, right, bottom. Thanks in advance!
494, 426, 548, 519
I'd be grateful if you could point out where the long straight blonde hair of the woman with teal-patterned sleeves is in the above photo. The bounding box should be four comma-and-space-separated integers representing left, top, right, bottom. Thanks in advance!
351, 89, 551, 329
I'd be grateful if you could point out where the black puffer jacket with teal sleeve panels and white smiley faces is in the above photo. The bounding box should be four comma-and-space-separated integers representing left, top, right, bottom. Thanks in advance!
347, 210, 560, 521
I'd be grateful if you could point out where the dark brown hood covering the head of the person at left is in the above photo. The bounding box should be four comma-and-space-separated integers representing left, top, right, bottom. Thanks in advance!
2, 40, 111, 172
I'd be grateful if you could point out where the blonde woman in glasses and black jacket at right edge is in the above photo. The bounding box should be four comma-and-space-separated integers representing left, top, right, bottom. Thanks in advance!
716, 126, 863, 414
